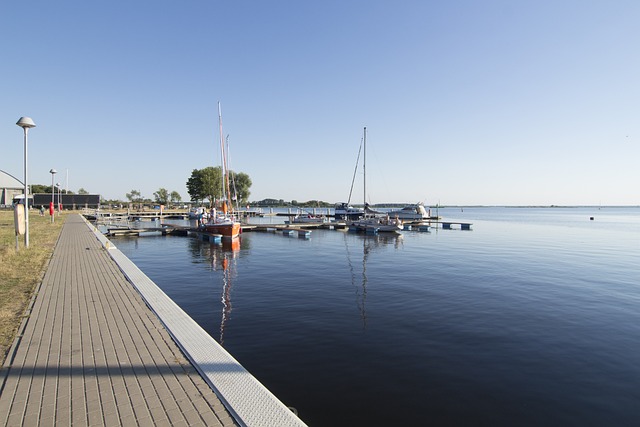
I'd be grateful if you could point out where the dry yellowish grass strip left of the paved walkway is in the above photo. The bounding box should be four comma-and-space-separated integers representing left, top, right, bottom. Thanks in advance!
0, 210, 66, 363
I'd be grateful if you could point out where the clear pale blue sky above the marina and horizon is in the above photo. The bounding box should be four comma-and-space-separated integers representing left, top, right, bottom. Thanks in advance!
0, 0, 640, 205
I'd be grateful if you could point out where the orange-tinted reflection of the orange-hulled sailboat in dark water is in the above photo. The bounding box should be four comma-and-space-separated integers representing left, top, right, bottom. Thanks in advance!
210, 237, 241, 345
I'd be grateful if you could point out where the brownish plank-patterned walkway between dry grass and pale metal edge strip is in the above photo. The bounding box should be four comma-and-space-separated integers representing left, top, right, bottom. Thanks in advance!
0, 215, 236, 426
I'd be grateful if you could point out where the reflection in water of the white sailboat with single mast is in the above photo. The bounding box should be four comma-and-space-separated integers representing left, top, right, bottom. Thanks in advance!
344, 233, 402, 329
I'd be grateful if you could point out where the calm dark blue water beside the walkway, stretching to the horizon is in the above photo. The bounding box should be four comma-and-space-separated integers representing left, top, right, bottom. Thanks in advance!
116, 208, 640, 426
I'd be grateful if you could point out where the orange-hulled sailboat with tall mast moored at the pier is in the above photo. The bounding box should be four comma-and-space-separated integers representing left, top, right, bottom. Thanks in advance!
204, 102, 242, 239
